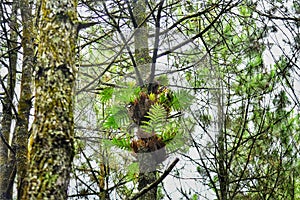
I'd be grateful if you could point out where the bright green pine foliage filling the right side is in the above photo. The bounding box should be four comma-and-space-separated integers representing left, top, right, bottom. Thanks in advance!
180, 2, 299, 199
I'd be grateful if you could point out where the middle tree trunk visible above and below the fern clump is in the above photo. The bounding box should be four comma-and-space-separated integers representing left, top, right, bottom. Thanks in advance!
133, 0, 157, 200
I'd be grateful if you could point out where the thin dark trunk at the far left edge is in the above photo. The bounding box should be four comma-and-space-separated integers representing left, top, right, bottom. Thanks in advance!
0, 1, 18, 199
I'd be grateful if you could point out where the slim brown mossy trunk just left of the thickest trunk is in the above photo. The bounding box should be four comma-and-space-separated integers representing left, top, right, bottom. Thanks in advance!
13, 0, 34, 199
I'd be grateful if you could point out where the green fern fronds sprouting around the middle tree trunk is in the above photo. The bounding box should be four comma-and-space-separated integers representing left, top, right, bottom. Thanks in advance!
98, 83, 193, 159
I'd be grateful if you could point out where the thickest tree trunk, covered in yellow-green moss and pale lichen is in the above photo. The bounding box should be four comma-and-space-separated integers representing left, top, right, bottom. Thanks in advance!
22, 0, 77, 199
